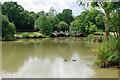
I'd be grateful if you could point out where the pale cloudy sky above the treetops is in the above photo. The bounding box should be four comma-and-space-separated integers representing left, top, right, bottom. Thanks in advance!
0, 0, 84, 16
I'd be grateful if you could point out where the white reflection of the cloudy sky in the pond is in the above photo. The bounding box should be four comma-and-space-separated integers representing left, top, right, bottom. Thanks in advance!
3, 53, 94, 78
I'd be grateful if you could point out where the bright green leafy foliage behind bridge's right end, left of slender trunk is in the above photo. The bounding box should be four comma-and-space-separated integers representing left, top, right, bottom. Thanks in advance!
70, 9, 104, 33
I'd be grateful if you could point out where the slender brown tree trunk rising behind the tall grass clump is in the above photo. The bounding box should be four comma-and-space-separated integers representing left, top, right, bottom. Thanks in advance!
104, 10, 109, 40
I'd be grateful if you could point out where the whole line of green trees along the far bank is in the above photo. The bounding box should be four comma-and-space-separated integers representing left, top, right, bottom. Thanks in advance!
2, 1, 120, 39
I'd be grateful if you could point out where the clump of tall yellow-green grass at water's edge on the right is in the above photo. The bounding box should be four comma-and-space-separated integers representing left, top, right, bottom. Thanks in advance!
95, 37, 120, 68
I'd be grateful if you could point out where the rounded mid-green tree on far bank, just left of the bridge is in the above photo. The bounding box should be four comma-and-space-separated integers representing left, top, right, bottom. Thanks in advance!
34, 16, 53, 36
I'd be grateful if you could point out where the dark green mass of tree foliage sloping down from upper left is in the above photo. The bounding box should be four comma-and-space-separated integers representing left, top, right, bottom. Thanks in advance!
2, 1, 36, 31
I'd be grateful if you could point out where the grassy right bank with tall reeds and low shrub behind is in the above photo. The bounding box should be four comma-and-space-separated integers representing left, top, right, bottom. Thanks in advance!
85, 34, 120, 68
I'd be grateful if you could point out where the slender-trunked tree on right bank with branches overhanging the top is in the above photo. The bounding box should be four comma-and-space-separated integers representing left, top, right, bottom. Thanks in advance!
78, 0, 120, 40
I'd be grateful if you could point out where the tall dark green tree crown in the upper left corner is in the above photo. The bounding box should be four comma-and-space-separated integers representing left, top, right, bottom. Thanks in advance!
2, 1, 24, 22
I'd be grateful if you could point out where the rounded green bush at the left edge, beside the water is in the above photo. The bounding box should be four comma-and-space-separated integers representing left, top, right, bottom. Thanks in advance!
2, 15, 16, 41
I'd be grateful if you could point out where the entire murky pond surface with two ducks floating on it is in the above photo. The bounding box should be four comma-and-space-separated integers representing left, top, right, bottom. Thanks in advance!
1, 38, 118, 78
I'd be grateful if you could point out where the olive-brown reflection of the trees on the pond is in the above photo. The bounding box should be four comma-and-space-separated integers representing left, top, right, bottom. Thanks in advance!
2, 38, 91, 73
